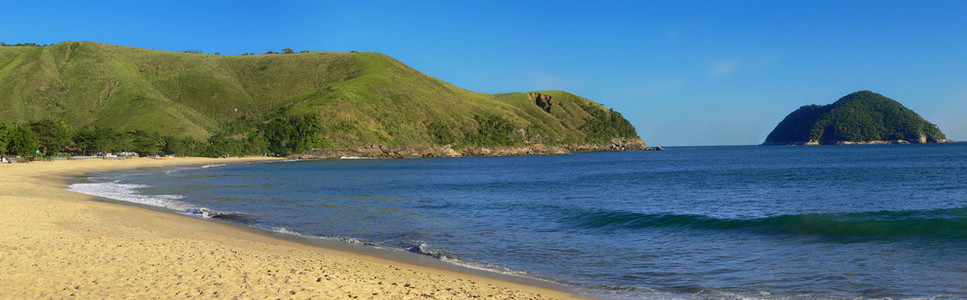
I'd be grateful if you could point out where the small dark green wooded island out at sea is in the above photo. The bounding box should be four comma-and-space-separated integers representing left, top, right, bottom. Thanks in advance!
763, 91, 950, 145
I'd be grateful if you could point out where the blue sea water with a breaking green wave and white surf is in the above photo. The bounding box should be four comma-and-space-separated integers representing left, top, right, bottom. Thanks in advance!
72, 143, 967, 298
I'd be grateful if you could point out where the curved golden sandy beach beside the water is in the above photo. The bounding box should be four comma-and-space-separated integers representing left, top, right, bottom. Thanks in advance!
0, 158, 573, 299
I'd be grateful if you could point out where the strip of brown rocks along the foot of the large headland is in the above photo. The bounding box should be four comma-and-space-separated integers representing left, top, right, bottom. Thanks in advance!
289, 138, 664, 159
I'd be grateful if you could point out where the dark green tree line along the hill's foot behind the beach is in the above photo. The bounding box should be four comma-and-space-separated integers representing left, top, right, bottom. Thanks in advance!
0, 115, 332, 158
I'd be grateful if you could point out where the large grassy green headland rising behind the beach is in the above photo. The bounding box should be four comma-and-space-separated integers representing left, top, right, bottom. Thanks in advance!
0, 42, 644, 155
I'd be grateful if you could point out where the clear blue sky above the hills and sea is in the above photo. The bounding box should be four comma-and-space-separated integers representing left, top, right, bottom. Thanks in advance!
0, 0, 967, 146
